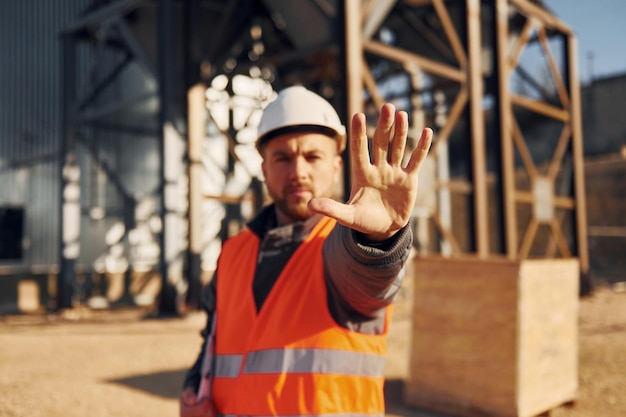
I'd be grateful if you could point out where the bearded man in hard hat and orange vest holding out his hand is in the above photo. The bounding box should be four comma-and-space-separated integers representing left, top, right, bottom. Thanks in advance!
180, 86, 432, 417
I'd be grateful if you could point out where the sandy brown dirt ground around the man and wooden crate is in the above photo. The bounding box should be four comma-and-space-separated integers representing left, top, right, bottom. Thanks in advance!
0, 287, 626, 417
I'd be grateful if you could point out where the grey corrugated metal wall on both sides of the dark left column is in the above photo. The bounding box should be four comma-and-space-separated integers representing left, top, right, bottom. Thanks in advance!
0, 0, 185, 296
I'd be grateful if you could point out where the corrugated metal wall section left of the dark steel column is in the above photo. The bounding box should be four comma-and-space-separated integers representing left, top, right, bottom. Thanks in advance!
0, 0, 90, 270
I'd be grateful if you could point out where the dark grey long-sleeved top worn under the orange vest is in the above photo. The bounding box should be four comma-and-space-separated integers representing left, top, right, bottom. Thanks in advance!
184, 205, 412, 389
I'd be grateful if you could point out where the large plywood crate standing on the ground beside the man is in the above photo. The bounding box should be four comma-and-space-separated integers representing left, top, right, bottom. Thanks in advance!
404, 258, 579, 417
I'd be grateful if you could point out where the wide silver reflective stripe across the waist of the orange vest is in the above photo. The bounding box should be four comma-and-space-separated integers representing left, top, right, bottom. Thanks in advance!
215, 349, 385, 378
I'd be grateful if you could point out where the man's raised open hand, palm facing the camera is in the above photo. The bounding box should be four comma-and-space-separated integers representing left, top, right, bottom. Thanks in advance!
309, 103, 433, 241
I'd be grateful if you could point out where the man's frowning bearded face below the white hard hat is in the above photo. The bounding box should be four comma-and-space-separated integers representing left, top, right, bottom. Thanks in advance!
261, 133, 342, 224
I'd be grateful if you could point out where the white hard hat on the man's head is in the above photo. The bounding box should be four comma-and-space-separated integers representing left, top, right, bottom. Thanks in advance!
256, 86, 346, 152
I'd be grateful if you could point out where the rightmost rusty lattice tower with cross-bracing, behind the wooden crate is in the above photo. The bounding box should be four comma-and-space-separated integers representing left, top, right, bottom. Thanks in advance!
496, 0, 589, 273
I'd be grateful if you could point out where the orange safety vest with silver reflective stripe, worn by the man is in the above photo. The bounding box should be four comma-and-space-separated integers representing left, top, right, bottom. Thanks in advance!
212, 218, 390, 417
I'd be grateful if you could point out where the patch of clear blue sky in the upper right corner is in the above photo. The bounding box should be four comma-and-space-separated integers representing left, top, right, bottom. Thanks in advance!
544, 0, 626, 84
